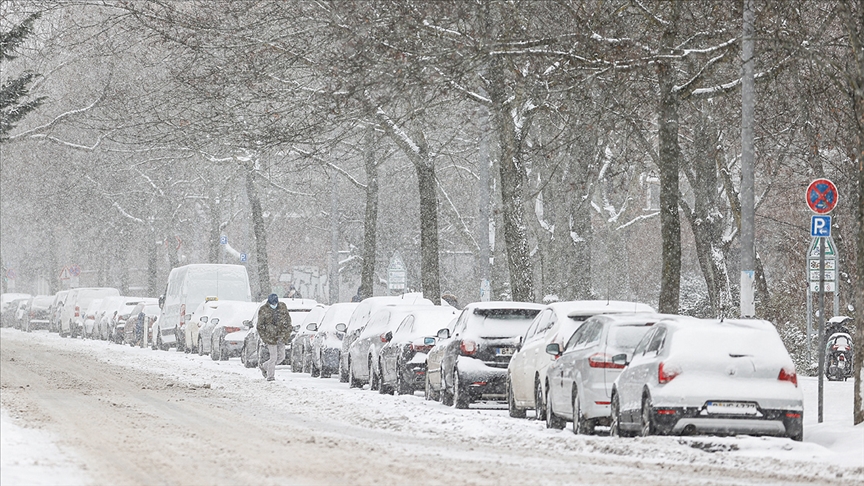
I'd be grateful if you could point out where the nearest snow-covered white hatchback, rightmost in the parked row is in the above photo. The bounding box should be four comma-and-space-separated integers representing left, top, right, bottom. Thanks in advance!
610, 318, 804, 441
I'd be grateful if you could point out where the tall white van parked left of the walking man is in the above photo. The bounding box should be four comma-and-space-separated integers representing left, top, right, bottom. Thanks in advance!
150, 264, 252, 351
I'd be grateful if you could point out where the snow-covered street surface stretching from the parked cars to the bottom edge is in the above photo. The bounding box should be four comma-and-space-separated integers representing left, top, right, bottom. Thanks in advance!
0, 329, 864, 486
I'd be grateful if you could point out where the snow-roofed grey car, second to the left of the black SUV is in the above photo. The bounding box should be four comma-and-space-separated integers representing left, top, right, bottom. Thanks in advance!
348, 303, 433, 393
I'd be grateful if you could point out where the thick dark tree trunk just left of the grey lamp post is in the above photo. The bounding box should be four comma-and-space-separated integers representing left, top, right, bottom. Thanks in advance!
657, 1, 681, 314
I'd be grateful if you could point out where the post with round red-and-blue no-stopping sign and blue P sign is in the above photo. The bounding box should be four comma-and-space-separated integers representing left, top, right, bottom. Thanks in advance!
806, 179, 840, 424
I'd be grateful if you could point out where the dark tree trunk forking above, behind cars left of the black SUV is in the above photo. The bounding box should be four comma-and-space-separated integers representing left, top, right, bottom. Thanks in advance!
414, 156, 441, 305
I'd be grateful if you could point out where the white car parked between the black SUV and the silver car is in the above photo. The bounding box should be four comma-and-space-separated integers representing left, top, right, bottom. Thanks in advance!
507, 300, 654, 420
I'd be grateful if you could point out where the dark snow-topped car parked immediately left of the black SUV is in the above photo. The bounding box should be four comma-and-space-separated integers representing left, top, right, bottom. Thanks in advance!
378, 306, 459, 395
